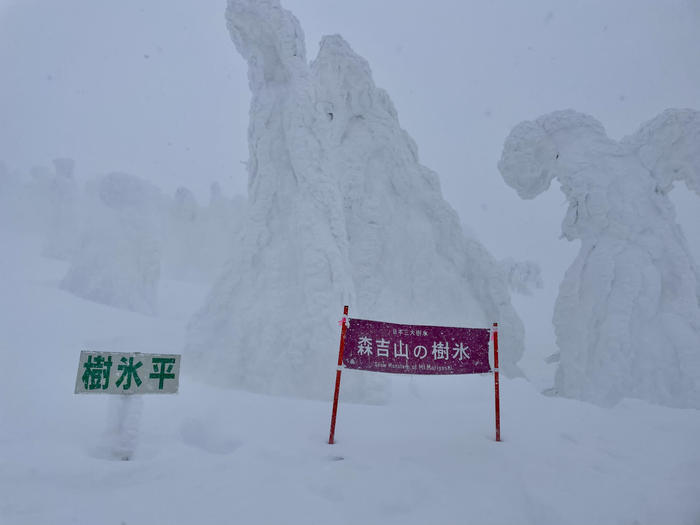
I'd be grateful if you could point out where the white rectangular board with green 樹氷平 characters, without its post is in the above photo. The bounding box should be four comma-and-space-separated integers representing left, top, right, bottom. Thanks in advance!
75, 351, 180, 394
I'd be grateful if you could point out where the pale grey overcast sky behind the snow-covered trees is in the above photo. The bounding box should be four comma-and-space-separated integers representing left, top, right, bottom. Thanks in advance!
0, 0, 700, 376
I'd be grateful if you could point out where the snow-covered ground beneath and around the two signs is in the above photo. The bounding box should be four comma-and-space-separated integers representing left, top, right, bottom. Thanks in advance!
0, 232, 700, 525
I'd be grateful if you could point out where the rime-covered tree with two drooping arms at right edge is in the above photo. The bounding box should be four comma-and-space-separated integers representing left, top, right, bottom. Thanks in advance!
498, 110, 700, 408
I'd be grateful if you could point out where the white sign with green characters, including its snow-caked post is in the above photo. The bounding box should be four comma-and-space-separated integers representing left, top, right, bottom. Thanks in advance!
75, 351, 180, 461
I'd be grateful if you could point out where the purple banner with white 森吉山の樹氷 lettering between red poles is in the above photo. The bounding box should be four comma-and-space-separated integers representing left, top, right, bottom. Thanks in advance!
343, 319, 491, 374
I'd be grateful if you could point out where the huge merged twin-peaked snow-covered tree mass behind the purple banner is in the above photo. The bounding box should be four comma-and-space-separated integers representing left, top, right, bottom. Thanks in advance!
186, 0, 523, 402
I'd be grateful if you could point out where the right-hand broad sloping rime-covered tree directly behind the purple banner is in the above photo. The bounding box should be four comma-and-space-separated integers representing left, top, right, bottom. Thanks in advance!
311, 35, 523, 364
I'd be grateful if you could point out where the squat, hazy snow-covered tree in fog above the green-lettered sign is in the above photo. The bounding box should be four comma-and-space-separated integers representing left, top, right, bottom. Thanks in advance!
60, 173, 163, 314
